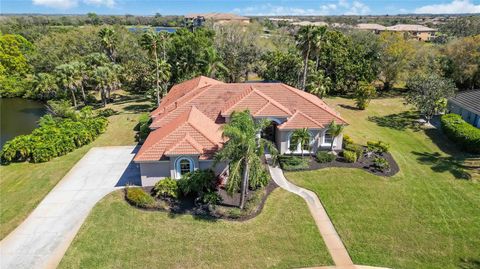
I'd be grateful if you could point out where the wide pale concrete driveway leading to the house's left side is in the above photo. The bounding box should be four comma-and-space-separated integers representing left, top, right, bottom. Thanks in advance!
0, 146, 140, 269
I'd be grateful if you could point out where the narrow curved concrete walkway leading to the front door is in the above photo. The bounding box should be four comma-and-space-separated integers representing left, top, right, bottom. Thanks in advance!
267, 161, 390, 269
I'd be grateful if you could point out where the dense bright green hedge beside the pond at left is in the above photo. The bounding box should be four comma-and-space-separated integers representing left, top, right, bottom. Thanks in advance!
1, 110, 108, 163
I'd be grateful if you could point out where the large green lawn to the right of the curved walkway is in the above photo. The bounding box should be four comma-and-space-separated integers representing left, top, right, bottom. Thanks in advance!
287, 98, 480, 269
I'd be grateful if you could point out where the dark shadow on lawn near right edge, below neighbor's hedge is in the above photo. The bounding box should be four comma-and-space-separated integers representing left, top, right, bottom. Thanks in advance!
412, 151, 479, 180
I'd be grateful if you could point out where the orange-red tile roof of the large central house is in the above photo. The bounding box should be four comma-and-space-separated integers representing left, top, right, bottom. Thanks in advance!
135, 77, 346, 161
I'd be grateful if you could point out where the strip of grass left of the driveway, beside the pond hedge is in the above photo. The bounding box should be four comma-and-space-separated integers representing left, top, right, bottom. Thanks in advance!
0, 94, 147, 239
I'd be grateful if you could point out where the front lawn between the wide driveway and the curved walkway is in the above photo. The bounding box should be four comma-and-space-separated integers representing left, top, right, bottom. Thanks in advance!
59, 189, 333, 268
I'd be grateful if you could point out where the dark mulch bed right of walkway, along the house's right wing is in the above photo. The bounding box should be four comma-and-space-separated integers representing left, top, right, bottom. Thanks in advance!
303, 149, 400, 177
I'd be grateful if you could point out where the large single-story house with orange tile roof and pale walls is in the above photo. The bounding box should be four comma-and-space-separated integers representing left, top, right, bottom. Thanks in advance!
134, 76, 346, 185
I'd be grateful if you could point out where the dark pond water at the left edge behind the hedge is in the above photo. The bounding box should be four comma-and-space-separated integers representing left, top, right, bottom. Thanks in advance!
0, 98, 47, 148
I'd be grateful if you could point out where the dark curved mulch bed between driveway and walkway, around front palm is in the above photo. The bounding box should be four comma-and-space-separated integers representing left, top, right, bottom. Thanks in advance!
125, 180, 278, 221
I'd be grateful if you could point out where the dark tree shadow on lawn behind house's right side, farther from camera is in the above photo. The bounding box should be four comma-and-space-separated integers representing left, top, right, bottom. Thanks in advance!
368, 111, 421, 131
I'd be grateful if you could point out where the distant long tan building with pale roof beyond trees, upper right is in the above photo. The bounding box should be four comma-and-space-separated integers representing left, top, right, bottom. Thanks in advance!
355, 23, 437, 41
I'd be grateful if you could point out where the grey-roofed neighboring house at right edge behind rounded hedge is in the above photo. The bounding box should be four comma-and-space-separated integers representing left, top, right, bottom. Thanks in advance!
447, 90, 480, 128
